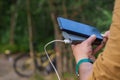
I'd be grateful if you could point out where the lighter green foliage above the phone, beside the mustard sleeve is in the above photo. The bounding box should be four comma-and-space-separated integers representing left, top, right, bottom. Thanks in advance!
64, 0, 114, 32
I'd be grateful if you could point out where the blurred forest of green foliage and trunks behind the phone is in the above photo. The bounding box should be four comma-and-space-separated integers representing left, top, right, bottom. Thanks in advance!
0, 0, 114, 79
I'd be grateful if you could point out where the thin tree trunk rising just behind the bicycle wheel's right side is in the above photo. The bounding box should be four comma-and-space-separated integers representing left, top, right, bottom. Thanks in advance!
26, 0, 35, 70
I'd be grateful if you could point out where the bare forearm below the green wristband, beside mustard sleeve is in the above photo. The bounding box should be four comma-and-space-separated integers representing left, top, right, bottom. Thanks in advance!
79, 62, 93, 80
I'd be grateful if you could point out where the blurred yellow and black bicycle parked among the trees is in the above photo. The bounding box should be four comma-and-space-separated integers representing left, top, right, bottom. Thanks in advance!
13, 50, 56, 77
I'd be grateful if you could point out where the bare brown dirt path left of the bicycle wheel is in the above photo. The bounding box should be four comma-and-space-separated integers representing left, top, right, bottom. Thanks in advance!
0, 55, 30, 80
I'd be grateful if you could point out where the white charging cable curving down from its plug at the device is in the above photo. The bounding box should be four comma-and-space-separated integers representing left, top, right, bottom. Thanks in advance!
44, 39, 71, 80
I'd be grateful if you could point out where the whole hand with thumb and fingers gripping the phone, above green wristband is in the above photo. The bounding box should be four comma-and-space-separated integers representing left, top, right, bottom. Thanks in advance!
72, 31, 110, 62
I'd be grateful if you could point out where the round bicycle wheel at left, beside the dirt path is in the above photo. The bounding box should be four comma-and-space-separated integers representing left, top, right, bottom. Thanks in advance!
13, 54, 37, 77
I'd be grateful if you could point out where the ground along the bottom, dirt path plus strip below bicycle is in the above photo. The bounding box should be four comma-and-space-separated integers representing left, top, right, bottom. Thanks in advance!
0, 55, 76, 80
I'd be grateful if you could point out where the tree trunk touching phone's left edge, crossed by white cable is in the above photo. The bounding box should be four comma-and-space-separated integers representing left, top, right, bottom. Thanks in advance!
48, 0, 63, 76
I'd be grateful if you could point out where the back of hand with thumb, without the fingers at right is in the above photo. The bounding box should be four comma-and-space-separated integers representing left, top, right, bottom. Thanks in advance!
72, 35, 96, 62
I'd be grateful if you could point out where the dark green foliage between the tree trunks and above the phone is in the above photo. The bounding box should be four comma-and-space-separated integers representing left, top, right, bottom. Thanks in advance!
0, 0, 114, 52
